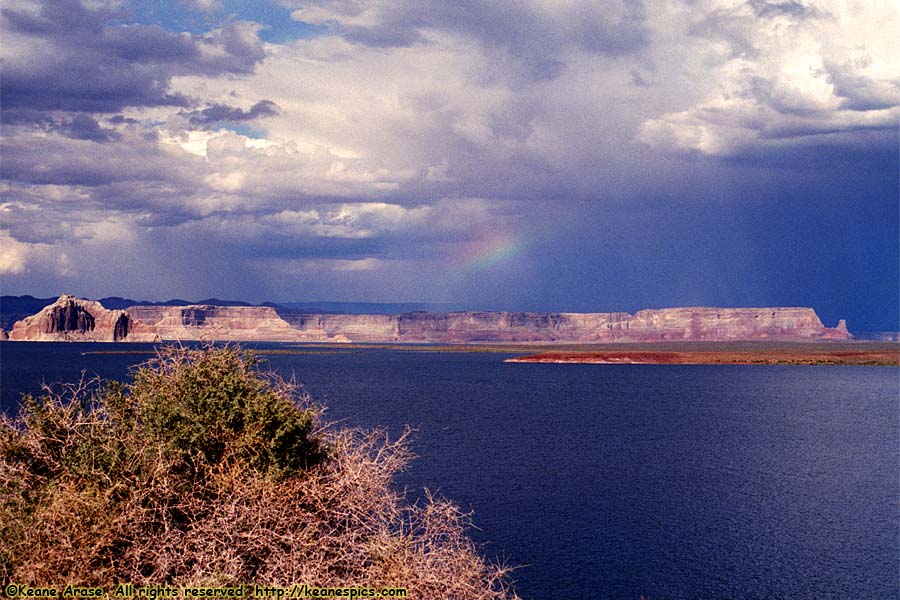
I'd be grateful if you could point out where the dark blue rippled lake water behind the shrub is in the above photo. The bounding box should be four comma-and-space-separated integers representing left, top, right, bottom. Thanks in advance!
0, 343, 900, 600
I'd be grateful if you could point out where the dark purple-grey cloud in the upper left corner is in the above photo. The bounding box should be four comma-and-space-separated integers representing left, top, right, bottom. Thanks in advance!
0, 0, 265, 112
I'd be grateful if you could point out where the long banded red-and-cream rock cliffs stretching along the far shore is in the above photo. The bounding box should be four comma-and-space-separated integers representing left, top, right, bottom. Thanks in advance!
11, 296, 852, 344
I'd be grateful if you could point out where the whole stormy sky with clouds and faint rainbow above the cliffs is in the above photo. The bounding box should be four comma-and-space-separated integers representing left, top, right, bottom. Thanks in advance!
0, 0, 900, 331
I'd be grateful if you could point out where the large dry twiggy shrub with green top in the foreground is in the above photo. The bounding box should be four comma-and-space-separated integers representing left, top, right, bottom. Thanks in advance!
0, 347, 515, 600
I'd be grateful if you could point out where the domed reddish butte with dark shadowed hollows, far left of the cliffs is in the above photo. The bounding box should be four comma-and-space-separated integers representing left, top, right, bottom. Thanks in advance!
9, 294, 159, 342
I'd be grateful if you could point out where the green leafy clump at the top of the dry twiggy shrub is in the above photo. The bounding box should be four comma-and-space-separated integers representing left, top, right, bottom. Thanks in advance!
132, 347, 323, 477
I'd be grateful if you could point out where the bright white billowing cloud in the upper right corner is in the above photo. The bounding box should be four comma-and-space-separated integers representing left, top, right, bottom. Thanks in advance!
637, 0, 900, 156
